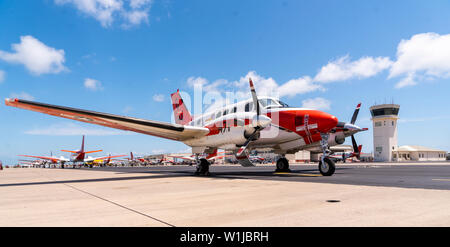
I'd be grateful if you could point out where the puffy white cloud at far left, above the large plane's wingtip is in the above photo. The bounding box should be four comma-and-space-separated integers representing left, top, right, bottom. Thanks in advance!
0, 35, 67, 75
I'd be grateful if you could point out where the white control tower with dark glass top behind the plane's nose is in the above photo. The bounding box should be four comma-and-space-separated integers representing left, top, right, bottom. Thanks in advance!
370, 104, 400, 162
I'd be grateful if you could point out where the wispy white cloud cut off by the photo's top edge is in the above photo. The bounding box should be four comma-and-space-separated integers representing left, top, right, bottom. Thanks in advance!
55, 0, 152, 27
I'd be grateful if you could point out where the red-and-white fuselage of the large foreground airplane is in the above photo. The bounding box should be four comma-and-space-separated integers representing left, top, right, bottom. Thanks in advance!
184, 97, 338, 152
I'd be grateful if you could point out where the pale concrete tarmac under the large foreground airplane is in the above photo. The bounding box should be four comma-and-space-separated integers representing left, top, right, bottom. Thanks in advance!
0, 162, 450, 227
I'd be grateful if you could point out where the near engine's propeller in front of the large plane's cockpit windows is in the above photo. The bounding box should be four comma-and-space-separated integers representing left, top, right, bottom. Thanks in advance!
236, 78, 272, 156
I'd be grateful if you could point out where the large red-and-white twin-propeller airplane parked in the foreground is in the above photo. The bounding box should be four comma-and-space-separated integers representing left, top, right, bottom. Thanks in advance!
5, 79, 367, 176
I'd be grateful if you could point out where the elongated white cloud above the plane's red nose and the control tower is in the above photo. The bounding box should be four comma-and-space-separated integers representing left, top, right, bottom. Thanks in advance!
314, 55, 393, 83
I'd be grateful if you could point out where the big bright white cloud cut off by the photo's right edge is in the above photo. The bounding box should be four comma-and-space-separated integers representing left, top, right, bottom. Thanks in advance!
388, 33, 450, 88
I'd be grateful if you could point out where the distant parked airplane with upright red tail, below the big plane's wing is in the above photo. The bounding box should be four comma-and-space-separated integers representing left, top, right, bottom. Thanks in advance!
19, 135, 126, 168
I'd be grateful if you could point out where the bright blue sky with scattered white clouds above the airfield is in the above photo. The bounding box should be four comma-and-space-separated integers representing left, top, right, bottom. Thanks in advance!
0, 0, 450, 163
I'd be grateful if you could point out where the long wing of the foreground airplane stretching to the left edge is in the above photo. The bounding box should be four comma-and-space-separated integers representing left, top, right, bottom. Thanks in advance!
5, 99, 209, 141
